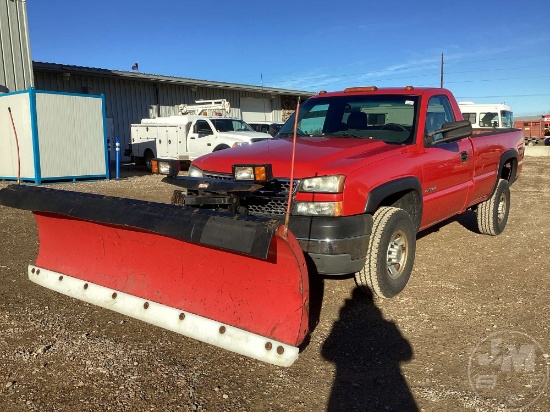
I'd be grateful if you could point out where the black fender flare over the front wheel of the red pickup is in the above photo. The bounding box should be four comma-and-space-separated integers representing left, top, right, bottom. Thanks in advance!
365, 176, 422, 229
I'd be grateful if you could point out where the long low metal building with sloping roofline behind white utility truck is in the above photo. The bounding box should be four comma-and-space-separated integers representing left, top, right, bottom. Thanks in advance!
33, 62, 314, 159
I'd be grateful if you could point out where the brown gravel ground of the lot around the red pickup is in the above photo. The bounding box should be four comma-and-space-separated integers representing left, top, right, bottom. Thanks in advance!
0, 157, 550, 412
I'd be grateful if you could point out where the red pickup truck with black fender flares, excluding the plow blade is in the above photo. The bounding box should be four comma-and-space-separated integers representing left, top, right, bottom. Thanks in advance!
156, 86, 524, 297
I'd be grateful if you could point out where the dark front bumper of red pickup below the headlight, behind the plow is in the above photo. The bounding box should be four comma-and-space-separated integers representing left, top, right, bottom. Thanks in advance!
289, 215, 372, 275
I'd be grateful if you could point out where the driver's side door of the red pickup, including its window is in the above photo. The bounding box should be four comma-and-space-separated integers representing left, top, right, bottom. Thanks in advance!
421, 95, 473, 226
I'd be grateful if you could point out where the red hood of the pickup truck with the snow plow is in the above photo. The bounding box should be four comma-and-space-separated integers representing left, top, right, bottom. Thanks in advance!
193, 137, 405, 178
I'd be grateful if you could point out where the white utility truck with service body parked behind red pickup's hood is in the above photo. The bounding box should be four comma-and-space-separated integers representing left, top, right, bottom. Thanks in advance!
125, 99, 271, 170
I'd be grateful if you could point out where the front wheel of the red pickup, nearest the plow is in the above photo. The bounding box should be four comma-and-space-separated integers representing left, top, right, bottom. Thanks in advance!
355, 207, 416, 298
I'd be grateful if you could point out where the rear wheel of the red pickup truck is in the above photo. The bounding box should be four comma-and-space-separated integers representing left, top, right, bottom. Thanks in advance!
476, 179, 510, 236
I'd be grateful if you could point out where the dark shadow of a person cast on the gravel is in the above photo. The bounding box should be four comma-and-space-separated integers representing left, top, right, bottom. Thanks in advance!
321, 288, 418, 412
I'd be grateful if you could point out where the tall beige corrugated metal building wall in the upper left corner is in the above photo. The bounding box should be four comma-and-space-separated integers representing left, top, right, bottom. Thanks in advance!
0, 0, 33, 92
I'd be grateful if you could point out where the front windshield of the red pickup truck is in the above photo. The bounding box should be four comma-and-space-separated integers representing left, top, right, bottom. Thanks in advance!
277, 95, 418, 144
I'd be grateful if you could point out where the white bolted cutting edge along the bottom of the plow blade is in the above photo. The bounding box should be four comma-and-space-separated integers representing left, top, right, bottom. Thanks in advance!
29, 265, 299, 366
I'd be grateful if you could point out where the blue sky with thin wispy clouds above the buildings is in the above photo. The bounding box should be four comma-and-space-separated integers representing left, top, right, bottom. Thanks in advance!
27, 0, 550, 116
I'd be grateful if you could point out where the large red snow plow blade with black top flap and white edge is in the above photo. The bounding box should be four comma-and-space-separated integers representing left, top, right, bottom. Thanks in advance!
0, 185, 309, 366
